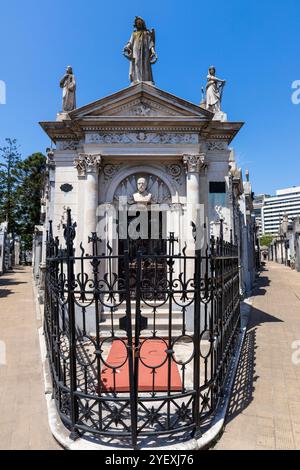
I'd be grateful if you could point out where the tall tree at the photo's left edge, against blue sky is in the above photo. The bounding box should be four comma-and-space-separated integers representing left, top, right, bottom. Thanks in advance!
0, 139, 21, 235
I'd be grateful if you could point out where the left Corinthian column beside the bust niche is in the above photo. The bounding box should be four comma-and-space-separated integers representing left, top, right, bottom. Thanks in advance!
74, 153, 101, 252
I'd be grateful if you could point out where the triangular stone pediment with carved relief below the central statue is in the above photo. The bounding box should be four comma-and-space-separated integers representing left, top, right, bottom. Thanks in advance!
69, 83, 213, 121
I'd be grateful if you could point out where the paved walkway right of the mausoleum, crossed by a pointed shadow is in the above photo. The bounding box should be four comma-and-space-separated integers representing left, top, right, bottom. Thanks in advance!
214, 263, 300, 450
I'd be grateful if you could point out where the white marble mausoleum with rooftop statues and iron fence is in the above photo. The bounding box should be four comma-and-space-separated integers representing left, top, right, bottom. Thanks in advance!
34, 17, 256, 449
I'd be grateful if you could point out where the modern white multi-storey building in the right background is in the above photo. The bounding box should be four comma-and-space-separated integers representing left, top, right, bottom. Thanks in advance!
254, 186, 300, 235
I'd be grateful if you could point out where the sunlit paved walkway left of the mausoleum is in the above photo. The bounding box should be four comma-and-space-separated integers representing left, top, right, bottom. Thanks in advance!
0, 267, 61, 450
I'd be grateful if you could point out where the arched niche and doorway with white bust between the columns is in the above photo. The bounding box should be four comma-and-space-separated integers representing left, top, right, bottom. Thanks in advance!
114, 172, 171, 298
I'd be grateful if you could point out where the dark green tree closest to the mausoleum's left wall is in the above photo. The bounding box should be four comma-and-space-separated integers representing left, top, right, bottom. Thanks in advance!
17, 152, 46, 249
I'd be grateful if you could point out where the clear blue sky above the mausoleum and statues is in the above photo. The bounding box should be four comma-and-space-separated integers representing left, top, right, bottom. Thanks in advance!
0, 0, 300, 193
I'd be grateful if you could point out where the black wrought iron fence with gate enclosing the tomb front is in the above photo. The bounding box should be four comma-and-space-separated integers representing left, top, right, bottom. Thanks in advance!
44, 210, 240, 448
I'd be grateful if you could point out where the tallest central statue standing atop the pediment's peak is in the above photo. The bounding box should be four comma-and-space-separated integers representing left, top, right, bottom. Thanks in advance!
123, 16, 157, 83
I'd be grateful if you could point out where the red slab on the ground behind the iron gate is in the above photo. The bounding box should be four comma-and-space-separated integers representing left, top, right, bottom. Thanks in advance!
101, 339, 182, 392
